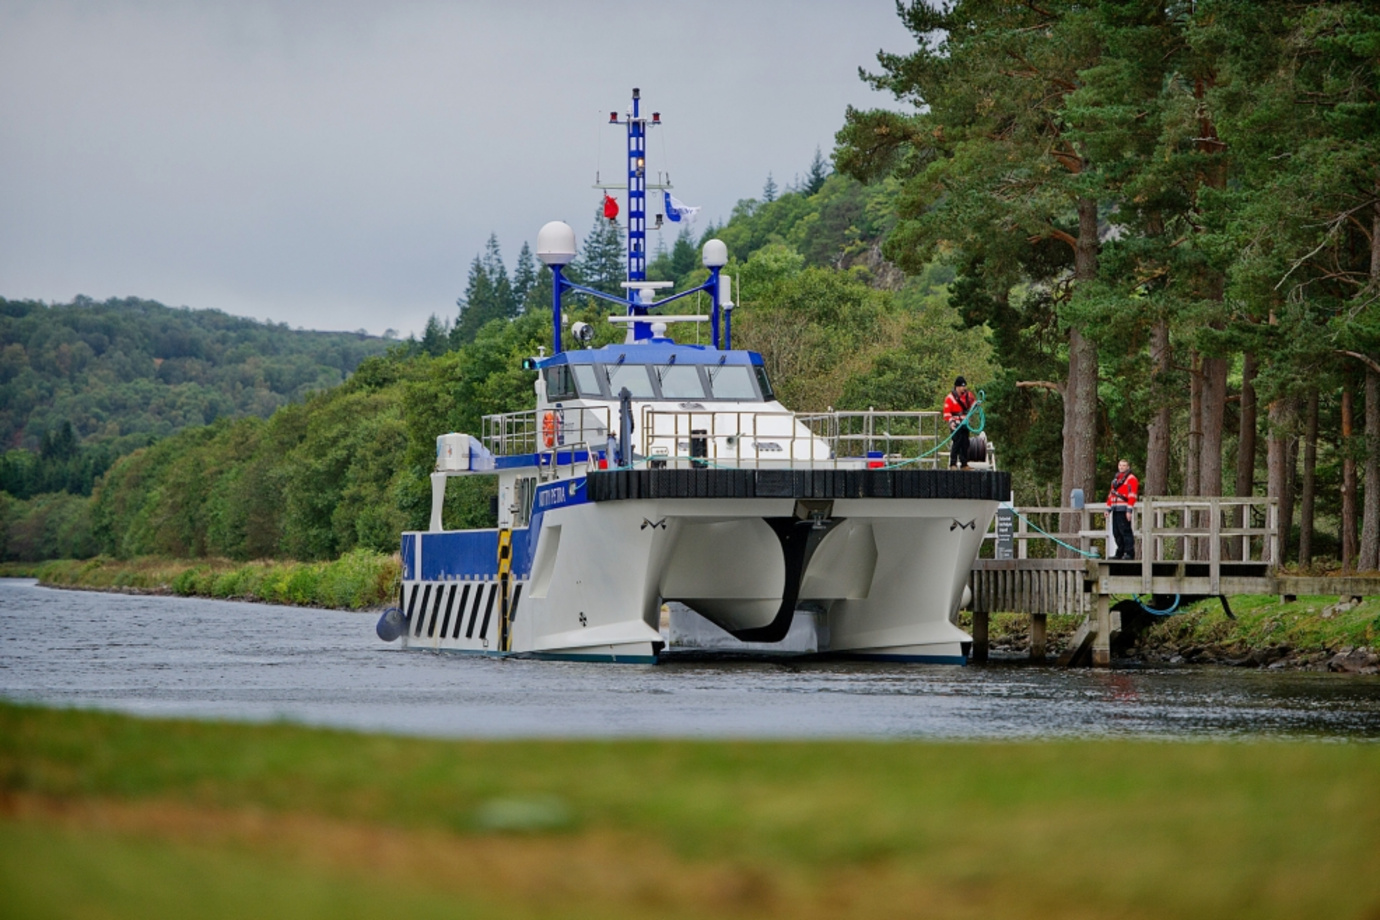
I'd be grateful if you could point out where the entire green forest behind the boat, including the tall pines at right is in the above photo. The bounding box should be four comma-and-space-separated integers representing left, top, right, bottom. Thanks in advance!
4, 0, 1380, 570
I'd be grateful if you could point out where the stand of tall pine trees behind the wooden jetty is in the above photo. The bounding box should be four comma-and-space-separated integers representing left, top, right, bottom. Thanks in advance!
835, 0, 1380, 570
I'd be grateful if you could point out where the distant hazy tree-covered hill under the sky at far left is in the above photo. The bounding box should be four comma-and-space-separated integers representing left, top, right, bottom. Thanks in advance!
0, 297, 391, 497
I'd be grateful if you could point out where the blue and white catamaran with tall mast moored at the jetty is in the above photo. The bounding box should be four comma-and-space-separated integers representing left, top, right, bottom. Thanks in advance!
378, 90, 1010, 663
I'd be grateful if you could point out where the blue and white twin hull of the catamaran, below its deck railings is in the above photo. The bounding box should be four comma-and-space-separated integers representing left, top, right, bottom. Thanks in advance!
402, 469, 1010, 663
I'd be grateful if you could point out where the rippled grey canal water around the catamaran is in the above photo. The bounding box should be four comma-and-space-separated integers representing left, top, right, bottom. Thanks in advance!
0, 579, 1380, 741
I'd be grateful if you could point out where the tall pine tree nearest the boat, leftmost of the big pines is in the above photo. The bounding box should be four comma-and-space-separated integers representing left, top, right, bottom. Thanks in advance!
833, 0, 1121, 528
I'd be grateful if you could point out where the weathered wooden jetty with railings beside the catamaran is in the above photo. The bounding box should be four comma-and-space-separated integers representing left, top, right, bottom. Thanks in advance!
969, 497, 1380, 668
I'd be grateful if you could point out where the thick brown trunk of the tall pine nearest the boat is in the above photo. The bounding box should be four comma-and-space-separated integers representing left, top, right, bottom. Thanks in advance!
1063, 199, 1097, 546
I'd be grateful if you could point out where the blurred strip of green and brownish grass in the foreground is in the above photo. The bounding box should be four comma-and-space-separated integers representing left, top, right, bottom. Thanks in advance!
0, 705, 1380, 920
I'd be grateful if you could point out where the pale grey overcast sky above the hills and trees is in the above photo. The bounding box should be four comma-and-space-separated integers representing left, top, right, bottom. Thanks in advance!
0, 0, 914, 335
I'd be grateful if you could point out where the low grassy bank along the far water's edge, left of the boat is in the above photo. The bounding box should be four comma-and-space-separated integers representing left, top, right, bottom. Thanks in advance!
33, 550, 402, 610
